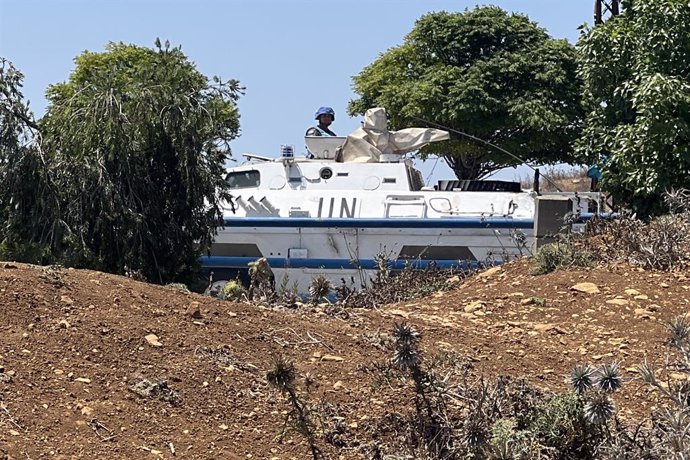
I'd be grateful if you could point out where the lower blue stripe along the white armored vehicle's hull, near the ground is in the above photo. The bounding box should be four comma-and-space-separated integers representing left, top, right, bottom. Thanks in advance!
201, 256, 492, 270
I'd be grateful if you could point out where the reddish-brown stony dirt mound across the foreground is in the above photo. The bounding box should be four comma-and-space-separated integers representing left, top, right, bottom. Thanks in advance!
0, 261, 690, 459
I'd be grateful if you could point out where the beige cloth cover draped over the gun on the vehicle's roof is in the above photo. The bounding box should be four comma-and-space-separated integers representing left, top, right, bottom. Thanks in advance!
338, 107, 450, 163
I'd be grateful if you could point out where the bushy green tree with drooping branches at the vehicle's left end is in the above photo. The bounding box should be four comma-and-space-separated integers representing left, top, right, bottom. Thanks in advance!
36, 40, 243, 283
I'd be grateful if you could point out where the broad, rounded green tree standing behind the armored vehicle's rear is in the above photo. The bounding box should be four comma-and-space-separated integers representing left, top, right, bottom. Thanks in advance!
348, 7, 582, 179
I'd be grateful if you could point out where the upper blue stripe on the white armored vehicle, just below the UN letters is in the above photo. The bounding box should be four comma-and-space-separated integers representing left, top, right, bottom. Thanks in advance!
224, 217, 534, 228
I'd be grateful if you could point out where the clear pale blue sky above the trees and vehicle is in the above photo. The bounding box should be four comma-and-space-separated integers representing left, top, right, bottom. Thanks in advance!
0, 0, 594, 183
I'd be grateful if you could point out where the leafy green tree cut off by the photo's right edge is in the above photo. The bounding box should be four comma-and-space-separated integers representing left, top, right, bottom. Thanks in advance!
576, 0, 690, 215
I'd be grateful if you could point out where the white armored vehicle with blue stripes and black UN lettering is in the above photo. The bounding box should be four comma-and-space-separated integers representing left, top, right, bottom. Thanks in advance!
202, 109, 596, 293
